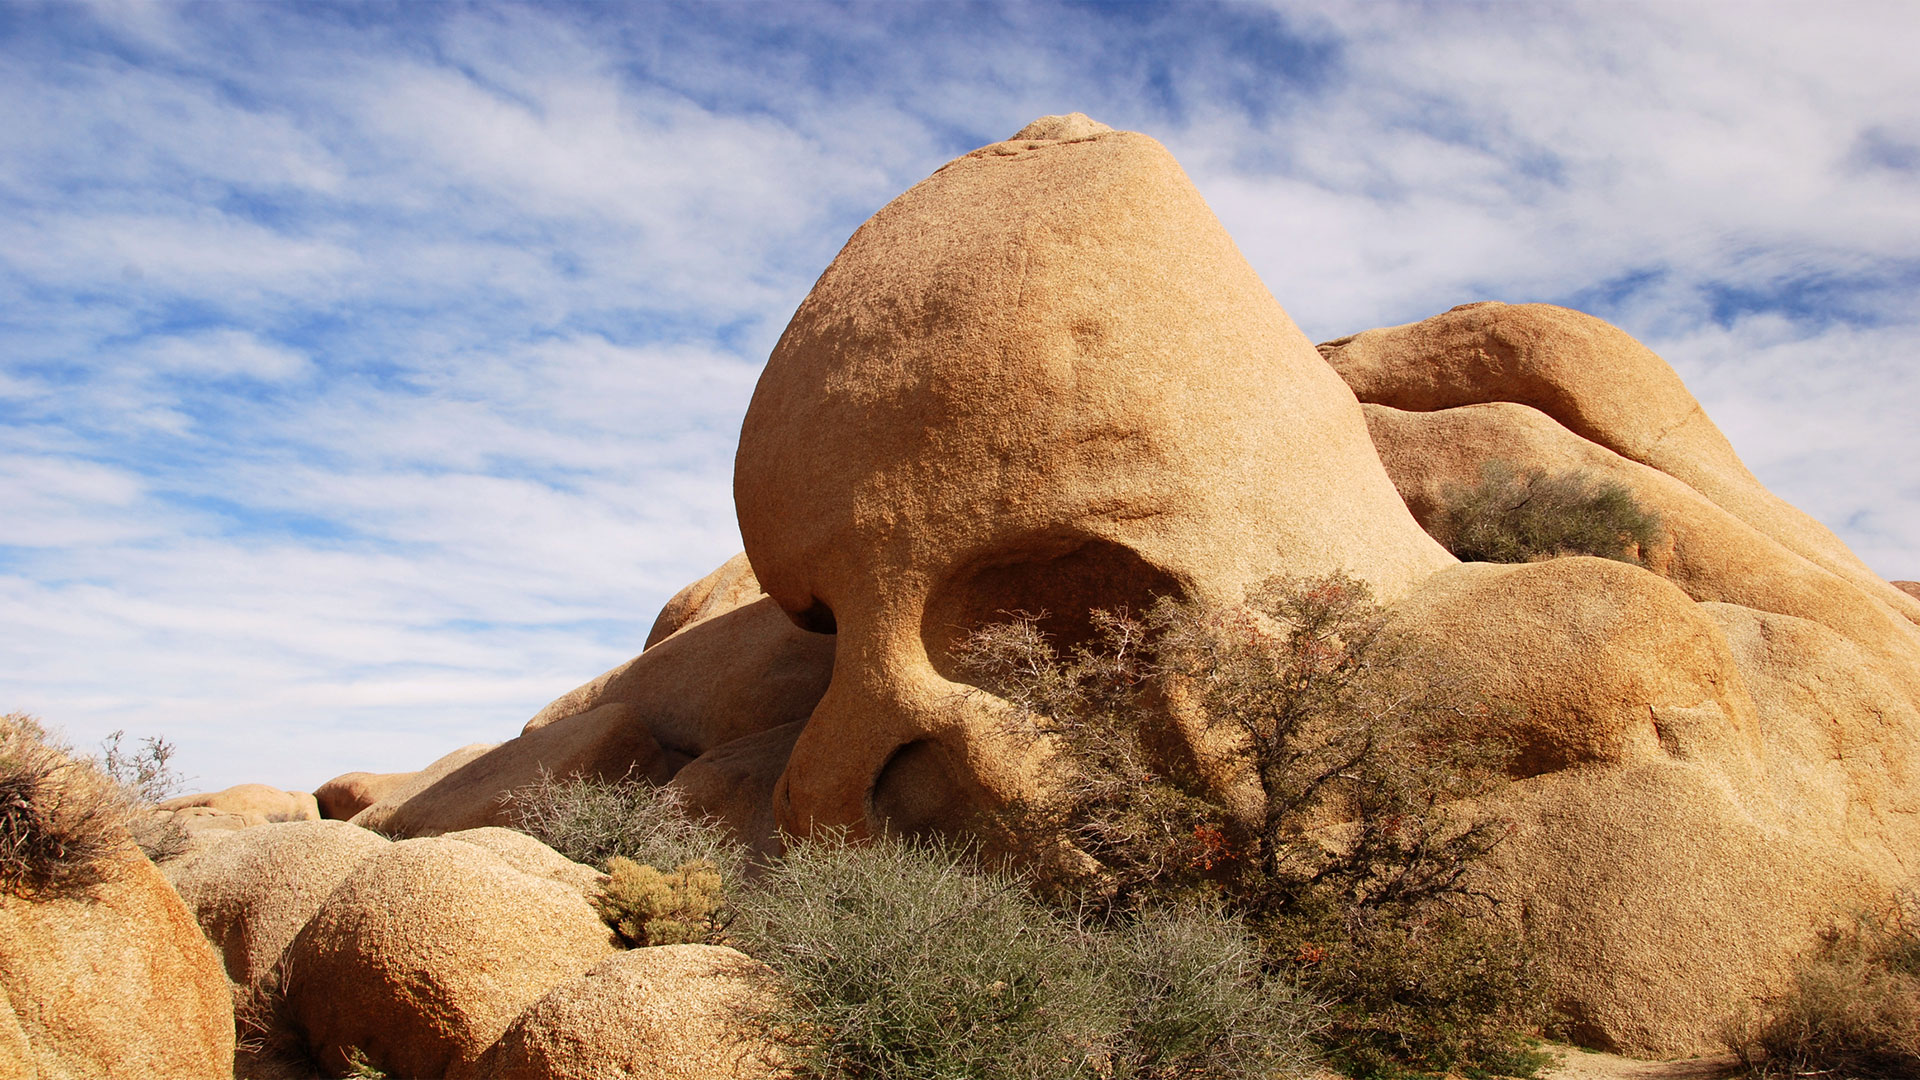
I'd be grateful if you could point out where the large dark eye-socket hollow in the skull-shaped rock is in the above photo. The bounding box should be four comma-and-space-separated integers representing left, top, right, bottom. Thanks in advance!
920, 536, 1185, 682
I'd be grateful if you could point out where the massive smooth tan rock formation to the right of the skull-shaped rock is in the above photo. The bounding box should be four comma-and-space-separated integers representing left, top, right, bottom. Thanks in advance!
1321, 304, 1920, 1055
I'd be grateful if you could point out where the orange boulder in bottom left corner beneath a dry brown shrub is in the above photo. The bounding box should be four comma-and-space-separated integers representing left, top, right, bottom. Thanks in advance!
0, 844, 234, 1080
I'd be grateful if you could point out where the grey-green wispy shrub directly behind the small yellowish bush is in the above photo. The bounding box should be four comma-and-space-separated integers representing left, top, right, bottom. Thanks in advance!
507, 773, 751, 880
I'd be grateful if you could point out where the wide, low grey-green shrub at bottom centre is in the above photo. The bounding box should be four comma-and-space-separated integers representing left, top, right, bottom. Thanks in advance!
733, 838, 1313, 1080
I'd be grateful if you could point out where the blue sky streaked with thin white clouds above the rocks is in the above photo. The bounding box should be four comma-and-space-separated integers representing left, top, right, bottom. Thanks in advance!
0, 0, 1920, 788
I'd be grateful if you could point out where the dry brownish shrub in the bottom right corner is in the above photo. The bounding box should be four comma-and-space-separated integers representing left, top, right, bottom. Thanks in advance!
1728, 892, 1920, 1080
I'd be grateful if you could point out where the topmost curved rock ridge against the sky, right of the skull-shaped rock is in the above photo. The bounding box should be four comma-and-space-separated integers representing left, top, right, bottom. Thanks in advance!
1320, 302, 1920, 623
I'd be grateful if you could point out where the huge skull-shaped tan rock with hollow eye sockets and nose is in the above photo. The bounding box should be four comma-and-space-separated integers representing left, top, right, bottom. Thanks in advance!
733, 115, 1453, 834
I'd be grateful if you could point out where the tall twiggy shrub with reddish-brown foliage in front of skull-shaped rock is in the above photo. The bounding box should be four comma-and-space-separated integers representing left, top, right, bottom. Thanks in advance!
956, 575, 1544, 1076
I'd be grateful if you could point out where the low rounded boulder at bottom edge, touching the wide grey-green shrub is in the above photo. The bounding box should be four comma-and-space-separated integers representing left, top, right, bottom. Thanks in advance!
459, 945, 781, 1080
